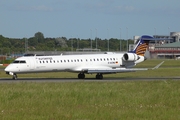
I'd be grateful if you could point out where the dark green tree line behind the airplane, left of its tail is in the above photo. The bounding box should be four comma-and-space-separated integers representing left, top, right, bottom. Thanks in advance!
0, 32, 133, 55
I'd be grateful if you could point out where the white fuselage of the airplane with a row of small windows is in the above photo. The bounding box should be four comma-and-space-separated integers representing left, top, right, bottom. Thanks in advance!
5, 54, 144, 74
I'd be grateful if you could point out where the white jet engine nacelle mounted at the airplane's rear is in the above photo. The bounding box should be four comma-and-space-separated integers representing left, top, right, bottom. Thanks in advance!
122, 53, 139, 61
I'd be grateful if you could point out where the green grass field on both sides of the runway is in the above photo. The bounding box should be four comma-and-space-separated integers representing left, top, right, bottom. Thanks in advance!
0, 60, 180, 120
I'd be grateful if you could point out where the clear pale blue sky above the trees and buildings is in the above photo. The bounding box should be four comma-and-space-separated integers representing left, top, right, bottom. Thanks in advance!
0, 0, 180, 39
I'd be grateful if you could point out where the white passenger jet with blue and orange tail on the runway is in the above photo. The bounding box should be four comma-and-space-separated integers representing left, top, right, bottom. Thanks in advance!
5, 35, 162, 80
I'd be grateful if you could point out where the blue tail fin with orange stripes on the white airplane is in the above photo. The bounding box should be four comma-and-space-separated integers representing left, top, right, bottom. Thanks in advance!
132, 35, 153, 56
